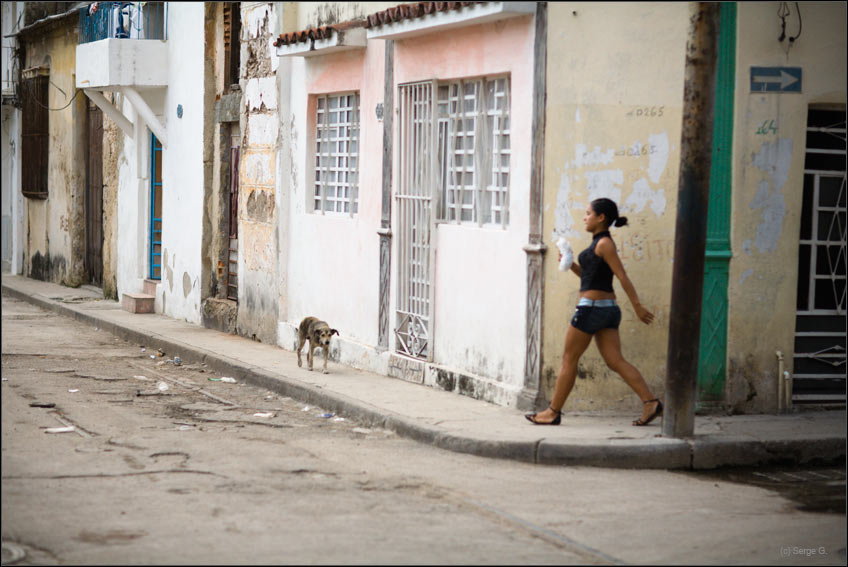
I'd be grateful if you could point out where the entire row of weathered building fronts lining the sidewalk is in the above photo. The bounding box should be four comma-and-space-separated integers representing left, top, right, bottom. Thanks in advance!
3, 2, 846, 418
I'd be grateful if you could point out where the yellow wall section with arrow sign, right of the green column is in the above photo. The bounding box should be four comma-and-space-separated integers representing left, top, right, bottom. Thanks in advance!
727, 2, 846, 412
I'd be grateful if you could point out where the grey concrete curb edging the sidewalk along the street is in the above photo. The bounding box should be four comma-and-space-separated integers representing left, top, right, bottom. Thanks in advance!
2, 283, 846, 470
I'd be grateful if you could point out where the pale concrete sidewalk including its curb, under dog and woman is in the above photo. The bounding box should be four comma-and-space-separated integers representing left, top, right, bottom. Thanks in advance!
2, 274, 846, 469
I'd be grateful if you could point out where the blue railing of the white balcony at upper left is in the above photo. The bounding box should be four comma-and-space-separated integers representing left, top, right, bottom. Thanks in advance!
79, 2, 168, 44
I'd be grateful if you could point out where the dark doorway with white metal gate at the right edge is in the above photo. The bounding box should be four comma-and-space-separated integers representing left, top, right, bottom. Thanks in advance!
792, 109, 848, 404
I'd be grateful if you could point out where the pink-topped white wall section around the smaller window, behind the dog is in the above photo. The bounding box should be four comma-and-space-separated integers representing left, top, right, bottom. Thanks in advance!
278, 46, 386, 370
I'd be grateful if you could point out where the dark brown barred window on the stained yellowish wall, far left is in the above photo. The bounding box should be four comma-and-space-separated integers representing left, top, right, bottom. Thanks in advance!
21, 70, 50, 199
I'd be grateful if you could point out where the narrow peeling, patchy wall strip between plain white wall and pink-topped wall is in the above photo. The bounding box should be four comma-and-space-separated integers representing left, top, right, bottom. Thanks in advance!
237, 3, 280, 344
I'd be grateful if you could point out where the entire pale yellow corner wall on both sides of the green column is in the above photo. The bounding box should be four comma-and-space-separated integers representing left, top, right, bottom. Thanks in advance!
542, 2, 846, 412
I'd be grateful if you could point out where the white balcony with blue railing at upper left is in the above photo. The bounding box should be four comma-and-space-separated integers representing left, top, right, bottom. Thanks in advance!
76, 2, 168, 90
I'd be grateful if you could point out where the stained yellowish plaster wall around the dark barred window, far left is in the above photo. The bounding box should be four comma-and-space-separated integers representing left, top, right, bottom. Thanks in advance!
23, 22, 87, 287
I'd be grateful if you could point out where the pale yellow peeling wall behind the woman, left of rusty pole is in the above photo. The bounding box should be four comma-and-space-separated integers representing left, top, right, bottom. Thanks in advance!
541, 2, 689, 414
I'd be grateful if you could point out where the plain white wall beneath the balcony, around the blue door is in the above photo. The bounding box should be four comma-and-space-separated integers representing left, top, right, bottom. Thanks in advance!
117, 2, 205, 324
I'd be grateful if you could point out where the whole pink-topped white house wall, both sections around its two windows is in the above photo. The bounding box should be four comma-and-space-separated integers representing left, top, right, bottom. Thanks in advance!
278, 13, 533, 405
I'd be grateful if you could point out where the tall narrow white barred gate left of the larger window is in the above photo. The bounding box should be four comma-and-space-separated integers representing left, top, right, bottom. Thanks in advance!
395, 82, 438, 360
